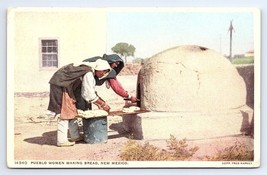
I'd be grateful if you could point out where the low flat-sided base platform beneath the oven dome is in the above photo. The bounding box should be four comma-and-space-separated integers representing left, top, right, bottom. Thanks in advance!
123, 106, 254, 140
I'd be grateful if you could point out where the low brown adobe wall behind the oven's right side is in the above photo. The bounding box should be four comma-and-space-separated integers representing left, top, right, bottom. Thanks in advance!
236, 64, 254, 109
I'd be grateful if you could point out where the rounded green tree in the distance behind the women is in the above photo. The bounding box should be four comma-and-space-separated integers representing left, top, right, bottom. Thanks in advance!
111, 42, 135, 62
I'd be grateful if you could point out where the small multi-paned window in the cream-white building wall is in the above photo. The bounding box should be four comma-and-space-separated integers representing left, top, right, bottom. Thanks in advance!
41, 39, 58, 68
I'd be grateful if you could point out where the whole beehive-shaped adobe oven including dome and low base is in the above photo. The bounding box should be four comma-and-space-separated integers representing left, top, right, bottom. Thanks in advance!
123, 46, 253, 139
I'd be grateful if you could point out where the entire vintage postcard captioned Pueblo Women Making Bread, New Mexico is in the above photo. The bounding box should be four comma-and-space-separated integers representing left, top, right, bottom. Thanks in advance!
7, 7, 261, 168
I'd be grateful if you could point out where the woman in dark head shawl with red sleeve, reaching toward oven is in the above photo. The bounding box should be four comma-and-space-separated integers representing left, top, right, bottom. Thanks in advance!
83, 54, 137, 103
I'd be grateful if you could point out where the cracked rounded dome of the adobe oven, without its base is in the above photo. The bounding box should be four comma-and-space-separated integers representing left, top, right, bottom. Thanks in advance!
138, 46, 246, 112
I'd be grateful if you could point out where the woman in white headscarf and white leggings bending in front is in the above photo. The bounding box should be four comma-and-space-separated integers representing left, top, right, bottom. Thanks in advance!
48, 60, 111, 146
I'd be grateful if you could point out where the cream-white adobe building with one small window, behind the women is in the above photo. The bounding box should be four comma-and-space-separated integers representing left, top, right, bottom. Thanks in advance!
7, 8, 109, 92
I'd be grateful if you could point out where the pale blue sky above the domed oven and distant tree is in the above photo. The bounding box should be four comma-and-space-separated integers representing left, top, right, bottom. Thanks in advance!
107, 11, 254, 58
